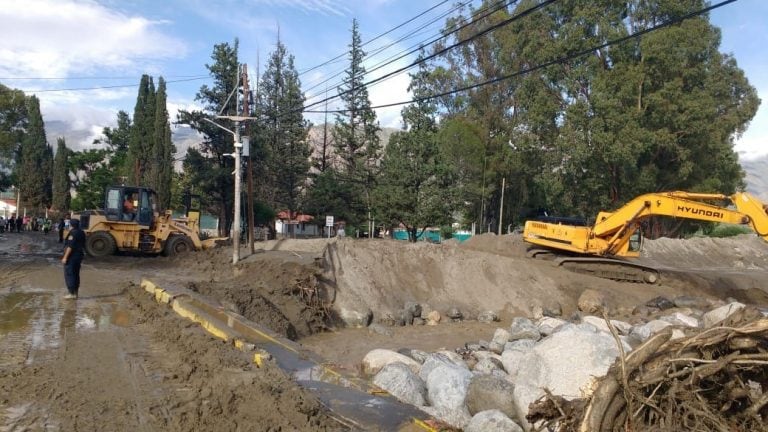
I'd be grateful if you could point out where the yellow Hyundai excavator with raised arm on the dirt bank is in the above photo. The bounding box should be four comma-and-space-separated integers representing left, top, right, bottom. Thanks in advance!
523, 192, 768, 283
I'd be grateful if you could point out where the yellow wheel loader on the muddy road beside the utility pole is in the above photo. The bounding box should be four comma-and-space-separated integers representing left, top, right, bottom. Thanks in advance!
73, 186, 212, 257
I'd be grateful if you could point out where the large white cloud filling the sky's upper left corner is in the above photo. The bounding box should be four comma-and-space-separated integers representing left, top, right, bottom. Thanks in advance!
0, 0, 186, 78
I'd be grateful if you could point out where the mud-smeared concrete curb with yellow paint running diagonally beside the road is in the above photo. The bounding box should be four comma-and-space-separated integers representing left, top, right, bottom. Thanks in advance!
141, 279, 437, 432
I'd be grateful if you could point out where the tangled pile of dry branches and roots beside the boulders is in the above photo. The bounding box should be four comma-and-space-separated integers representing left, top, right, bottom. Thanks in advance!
528, 308, 768, 432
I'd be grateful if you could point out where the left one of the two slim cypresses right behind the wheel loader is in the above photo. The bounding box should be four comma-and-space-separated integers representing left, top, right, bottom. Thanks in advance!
128, 75, 155, 185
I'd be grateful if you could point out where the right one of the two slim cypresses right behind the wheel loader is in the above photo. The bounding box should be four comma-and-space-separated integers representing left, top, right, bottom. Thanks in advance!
147, 77, 176, 210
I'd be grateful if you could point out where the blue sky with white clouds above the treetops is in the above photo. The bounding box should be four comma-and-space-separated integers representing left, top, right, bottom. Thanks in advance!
0, 0, 768, 158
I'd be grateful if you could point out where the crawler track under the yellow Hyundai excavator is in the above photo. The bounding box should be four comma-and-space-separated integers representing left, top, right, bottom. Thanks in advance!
528, 249, 660, 284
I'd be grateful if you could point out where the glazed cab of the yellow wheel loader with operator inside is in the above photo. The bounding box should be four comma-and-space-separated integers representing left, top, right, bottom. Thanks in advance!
104, 186, 157, 228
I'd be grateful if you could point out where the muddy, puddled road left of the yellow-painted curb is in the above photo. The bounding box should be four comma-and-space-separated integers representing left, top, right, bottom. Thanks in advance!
0, 232, 346, 431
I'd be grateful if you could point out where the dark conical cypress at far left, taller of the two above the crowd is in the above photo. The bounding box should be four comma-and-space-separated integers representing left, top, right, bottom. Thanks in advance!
16, 96, 52, 213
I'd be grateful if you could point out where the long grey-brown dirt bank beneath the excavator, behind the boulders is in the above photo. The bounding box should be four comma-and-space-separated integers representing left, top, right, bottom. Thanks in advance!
184, 234, 768, 339
